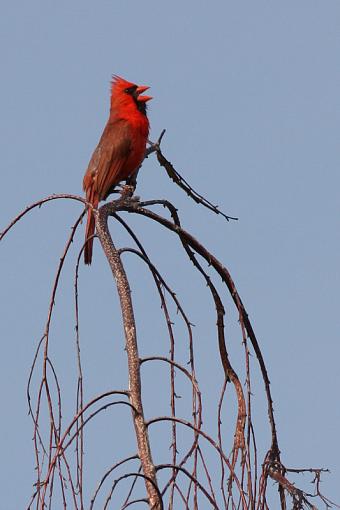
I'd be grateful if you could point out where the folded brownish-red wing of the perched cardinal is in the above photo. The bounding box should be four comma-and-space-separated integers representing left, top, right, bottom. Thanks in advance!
84, 119, 131, 201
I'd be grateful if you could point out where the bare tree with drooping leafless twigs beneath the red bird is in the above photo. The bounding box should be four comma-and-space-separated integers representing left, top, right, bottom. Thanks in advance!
0, 132, 339, 510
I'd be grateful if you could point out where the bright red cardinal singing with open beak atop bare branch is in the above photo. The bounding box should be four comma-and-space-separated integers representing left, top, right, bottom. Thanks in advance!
83, 76, 152, 264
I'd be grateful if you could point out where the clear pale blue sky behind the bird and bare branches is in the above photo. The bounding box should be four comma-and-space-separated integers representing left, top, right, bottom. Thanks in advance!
0, 0, 340, 510
